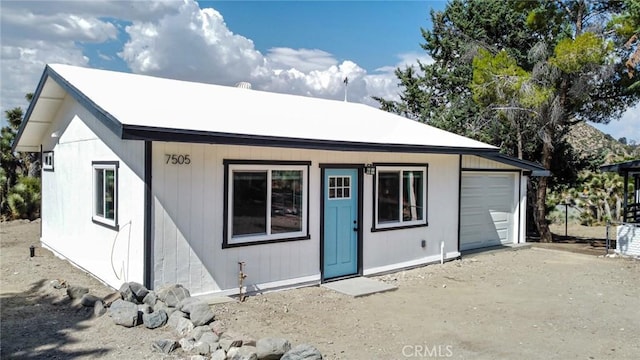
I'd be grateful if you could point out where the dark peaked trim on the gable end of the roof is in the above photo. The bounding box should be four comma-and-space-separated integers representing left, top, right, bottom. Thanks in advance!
11, 65, 122, 151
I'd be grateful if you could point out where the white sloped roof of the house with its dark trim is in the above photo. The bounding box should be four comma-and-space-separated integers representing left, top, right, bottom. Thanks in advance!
13, 64, 544, 174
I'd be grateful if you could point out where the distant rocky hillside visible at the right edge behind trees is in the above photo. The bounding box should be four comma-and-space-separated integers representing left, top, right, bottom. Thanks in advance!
567, 123, 640, 165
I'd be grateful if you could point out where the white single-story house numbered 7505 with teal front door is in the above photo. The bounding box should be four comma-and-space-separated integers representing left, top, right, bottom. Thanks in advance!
14, 65, 546, 294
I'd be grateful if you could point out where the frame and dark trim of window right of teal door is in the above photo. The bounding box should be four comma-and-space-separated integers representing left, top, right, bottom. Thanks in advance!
371, 163, 429, 232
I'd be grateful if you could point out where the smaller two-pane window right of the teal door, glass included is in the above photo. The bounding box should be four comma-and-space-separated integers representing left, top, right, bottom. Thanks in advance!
374, 165, 427, 230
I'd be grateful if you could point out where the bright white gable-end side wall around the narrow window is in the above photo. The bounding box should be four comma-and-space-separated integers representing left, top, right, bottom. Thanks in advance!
41, 97, 144, 288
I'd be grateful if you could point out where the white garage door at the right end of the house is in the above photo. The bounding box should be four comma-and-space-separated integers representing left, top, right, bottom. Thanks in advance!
460, 172, 517, 250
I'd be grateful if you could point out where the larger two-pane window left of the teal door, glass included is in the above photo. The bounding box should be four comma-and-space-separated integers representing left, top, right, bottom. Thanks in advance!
223, 161, 309, 247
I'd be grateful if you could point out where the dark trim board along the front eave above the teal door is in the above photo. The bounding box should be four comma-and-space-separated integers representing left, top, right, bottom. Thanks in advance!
122, 124, 497, 155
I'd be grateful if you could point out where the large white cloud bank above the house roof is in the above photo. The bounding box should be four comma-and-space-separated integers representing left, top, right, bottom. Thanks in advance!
0, 0, 429, 126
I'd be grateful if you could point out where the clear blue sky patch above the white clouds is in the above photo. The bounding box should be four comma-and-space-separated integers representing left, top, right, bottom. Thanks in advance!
199, 1, 438, 71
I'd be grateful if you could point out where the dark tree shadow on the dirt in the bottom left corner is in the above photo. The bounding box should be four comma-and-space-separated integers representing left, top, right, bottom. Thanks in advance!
0, 279, 108, 359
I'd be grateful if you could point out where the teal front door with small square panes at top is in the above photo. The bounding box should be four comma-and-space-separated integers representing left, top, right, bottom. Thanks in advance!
322, 169, 360, 279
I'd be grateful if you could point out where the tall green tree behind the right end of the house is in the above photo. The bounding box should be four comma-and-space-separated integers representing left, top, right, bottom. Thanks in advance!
381, 0, 640, 241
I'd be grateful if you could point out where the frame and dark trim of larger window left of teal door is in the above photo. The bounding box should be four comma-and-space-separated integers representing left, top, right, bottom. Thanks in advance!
222, 159, 311, 249
